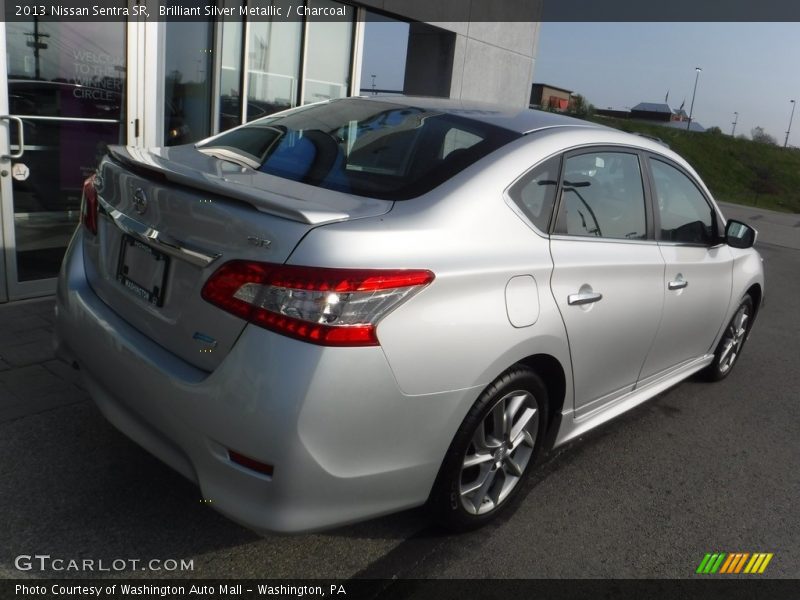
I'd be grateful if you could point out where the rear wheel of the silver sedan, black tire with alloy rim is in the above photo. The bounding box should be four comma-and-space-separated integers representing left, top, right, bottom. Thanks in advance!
429, 365, 548, 531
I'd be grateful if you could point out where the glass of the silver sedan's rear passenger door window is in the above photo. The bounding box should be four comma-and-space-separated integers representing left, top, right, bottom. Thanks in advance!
556, 152, 647, 240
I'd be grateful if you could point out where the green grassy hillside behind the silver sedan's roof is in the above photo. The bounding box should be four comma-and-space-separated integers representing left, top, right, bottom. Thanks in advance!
592, 116, 800, 213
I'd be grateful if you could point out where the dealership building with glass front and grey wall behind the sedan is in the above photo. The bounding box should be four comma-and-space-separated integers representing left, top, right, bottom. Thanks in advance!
0, 0, 539, 302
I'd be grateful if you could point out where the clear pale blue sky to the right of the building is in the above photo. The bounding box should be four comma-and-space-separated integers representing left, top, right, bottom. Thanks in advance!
533, 22, 800, 146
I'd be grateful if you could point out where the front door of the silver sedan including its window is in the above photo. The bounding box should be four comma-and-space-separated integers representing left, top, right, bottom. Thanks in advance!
640, 156, 733, 380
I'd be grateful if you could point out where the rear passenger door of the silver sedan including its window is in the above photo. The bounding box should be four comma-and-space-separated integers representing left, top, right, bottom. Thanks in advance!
550, 147, 664, 416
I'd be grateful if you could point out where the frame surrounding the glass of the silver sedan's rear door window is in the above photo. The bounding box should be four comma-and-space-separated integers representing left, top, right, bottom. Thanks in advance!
548, 144, 657, 244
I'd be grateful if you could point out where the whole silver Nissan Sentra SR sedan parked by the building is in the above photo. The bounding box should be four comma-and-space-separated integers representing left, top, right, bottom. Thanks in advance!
57, 97, 764, 531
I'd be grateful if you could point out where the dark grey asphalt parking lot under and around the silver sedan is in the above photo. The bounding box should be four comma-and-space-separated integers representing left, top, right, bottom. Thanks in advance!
0, 204, 800, 578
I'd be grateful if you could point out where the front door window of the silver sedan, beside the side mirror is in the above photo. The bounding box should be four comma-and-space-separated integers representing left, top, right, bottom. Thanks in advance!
650, 159, 715, 244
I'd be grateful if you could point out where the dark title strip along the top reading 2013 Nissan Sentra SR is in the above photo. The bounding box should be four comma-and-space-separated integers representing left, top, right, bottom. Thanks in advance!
4, 0, 800, 22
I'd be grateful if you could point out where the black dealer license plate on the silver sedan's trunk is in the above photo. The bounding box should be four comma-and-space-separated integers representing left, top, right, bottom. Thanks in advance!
117, 235, 169, 306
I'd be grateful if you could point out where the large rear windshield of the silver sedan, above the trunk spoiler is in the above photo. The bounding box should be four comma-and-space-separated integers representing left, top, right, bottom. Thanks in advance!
198, 98, 520, 200
